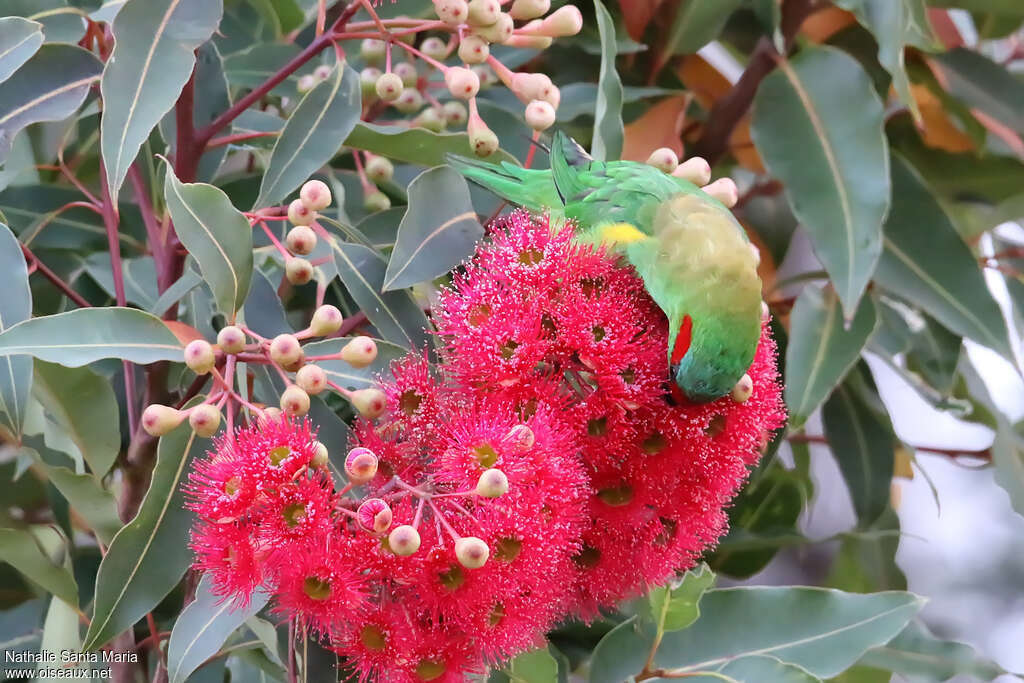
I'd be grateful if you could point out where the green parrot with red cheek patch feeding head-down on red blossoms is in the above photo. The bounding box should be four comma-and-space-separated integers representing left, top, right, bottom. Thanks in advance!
449, 131, 762, 402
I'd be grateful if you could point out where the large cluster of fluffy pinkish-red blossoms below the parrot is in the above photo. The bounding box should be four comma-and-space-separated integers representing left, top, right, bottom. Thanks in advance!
189, 213, 783, 682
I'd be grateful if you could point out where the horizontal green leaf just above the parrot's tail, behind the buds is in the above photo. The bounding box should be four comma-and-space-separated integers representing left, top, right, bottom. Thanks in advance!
345, 123, 519, 167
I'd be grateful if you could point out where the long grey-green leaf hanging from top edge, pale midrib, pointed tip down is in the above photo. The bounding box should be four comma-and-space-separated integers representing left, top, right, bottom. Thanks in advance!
99, 0, 223, 202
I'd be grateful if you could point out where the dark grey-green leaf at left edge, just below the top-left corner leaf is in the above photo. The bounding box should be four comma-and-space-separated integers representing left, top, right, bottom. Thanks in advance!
0, 43, 103, 163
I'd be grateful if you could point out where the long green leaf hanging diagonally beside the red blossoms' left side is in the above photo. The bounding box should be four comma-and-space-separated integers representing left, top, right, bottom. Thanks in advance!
84, 413, 208, 650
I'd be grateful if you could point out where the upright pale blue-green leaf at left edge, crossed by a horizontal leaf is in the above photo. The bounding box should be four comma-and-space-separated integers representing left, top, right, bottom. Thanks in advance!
0, 223, 32, 436
